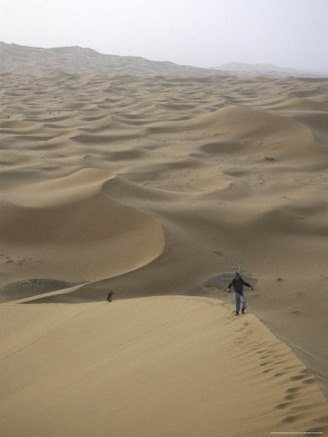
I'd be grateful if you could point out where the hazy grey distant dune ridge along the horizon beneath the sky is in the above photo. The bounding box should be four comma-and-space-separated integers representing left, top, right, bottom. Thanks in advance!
0, 42, 328, 78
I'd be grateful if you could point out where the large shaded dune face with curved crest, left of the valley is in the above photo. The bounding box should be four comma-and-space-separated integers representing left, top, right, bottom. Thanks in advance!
0, 169, 164, 281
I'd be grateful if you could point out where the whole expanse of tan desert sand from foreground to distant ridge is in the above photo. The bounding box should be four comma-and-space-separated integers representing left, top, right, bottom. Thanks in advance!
0, 45, 328, 437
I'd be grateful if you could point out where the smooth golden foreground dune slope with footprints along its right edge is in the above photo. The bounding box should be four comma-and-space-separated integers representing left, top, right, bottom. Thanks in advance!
0, 297, 328, 437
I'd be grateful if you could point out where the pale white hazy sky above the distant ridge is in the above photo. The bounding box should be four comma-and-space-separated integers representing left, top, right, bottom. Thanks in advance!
0, 0, 328, 72
